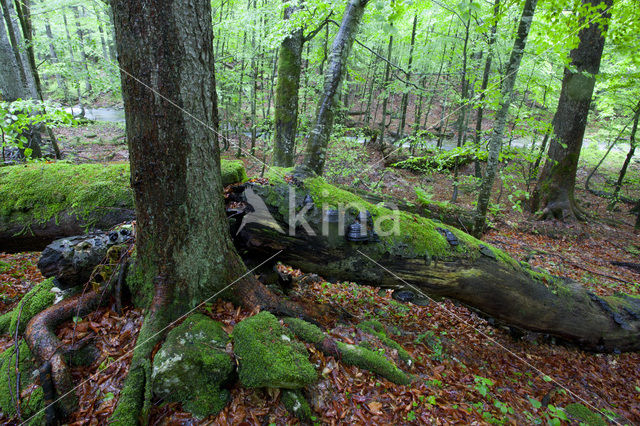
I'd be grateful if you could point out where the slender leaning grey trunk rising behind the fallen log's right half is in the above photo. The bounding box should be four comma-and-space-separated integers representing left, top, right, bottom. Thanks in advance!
474, 0, 538, 235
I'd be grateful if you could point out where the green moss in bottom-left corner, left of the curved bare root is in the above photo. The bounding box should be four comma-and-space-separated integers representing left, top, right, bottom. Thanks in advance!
0, 341, 44, 424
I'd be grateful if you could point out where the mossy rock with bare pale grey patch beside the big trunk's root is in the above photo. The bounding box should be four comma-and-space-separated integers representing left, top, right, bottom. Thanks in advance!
152, 314, 234, 418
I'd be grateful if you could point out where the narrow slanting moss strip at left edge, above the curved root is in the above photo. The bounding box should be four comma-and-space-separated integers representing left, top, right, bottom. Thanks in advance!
0, 278, 56, 335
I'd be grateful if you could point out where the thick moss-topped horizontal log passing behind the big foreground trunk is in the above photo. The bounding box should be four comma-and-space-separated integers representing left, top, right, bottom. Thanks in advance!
0, 160, 246, 252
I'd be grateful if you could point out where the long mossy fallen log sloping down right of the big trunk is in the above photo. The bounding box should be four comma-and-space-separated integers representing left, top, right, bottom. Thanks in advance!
232, 170, 640, 351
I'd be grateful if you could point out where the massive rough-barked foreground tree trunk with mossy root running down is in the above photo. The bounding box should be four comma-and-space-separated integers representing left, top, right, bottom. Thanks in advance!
112, 0, 302, 425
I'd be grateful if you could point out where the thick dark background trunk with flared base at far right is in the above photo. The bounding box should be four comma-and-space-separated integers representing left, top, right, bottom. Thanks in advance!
531, 0, 613, 220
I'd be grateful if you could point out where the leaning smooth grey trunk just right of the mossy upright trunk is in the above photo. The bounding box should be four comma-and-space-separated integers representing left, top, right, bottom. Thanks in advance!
304, 0, 368, 175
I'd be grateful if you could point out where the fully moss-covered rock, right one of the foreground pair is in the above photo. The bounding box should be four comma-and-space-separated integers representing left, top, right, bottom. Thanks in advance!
233, 312, 317, 389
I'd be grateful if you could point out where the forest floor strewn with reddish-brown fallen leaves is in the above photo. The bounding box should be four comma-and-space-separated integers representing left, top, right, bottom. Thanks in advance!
0, 124, 640, 425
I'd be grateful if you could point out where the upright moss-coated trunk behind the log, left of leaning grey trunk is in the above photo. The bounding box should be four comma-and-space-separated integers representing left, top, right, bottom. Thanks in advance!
272, 6, 304, 167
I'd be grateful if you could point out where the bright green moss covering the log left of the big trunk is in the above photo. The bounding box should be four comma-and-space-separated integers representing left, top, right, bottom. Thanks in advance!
0, 162, 133, 225
